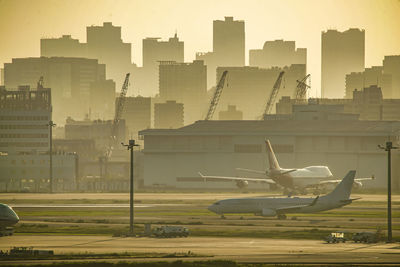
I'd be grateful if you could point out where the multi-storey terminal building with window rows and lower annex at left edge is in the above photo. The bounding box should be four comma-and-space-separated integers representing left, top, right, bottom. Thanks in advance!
0, 86, 78, 192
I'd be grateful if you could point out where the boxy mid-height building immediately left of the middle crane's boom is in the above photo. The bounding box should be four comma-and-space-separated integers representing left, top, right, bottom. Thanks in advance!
159, 60, 207, 124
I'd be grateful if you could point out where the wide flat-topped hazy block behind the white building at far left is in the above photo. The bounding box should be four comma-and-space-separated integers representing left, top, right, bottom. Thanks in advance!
4, 57, 107, 123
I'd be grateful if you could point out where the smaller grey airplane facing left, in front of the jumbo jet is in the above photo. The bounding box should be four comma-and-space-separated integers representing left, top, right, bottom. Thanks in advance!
208, 171, 356, 219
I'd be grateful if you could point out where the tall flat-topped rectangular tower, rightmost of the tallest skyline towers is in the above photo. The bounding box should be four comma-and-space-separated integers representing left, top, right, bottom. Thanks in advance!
321, 29, 365, 98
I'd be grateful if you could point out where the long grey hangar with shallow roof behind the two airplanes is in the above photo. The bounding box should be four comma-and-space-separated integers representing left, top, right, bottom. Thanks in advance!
139, 119, 400, 190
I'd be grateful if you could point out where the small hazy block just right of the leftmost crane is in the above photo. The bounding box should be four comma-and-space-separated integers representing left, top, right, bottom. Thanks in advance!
119, 96, 151, 138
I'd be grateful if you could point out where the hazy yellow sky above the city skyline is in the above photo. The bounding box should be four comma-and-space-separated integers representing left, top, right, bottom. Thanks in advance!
0, 0, 400, 94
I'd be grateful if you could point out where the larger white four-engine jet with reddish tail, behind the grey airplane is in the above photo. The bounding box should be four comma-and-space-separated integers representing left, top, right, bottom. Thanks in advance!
199, 140, 374, 195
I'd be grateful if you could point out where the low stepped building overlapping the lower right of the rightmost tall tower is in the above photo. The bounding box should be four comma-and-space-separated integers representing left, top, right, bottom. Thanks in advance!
346, 66, 392, 98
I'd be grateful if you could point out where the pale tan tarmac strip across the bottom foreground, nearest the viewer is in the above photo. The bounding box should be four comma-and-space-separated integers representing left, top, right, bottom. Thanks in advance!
0, 235, 400, 263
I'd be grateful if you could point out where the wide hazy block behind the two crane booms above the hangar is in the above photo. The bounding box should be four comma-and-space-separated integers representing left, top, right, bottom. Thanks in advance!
217, 64, 306, 120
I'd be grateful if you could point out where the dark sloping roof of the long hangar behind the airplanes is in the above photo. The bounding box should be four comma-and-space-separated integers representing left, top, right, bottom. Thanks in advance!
139, 120, 400, 136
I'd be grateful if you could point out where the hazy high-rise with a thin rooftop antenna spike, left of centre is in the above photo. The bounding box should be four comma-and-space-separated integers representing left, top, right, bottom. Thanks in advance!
138, 34, 184, 95
